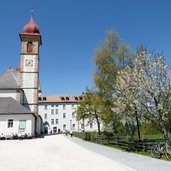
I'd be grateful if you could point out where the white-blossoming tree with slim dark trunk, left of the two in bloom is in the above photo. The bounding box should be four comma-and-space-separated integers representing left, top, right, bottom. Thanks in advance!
114, 66, 143, 140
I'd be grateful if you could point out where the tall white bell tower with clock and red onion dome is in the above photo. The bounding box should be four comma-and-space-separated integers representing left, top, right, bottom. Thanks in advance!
20, 16, 42, 115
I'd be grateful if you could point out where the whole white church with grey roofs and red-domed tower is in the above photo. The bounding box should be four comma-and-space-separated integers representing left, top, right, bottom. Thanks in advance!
0, 17, 42, 137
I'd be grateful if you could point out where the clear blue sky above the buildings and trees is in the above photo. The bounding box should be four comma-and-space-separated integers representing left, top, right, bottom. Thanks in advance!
0, 0, 171, 95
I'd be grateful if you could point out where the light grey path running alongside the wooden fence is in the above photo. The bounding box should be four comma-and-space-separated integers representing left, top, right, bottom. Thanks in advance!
68, 136, 171, 171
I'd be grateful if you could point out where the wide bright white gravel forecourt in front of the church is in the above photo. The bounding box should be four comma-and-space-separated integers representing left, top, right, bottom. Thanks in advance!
0, 135, 134, 171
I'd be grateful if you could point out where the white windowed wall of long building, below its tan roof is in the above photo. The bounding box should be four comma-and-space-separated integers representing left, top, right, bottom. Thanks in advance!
39, 102, 97, 133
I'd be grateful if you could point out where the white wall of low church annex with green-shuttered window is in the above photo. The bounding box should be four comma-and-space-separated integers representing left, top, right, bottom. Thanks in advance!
0, 114, 35, 136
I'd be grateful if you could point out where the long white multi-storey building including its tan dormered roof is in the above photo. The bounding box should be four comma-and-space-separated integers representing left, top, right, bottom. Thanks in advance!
39, 95, 97, 133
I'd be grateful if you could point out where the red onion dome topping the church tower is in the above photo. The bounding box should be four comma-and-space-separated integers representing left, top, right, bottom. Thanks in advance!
22, 17, 40, 34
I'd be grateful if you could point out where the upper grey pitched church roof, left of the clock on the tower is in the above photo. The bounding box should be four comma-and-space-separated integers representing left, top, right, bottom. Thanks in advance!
0, 68, 21, 89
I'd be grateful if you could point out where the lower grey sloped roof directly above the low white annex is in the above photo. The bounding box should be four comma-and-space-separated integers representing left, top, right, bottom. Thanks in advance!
0, 97, 33, 114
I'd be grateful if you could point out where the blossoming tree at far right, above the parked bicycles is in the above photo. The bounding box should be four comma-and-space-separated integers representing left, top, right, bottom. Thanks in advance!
137, 48, 171, 137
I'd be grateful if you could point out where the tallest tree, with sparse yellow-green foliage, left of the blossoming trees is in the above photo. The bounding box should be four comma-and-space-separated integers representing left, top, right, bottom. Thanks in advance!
94, 31, 133, 133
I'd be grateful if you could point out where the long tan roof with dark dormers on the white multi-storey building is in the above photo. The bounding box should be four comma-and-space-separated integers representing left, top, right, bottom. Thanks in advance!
39, 95, 83, 103
